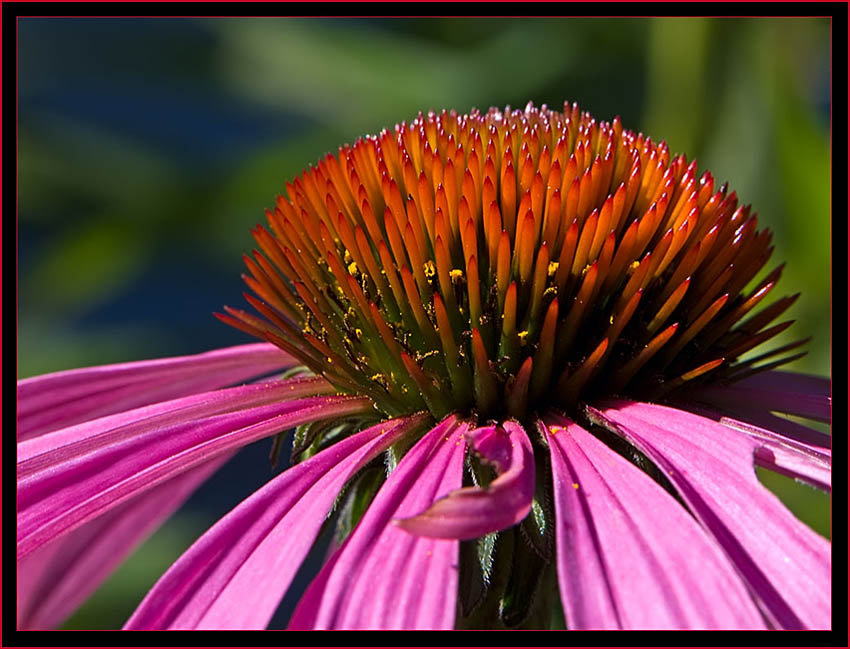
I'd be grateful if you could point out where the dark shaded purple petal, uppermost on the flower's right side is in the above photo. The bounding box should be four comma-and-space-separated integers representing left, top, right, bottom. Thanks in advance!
693, 371, 832, 422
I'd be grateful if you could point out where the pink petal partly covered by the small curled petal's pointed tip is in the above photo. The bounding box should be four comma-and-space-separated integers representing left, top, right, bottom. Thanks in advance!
289, 416, 466, 629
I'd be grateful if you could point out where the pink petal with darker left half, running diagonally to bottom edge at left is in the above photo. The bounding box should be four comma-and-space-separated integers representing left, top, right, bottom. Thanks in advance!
125, 416, 424, 629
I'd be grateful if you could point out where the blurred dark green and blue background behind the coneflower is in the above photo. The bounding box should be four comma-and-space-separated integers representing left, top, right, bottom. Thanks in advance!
18, 18, 831, 628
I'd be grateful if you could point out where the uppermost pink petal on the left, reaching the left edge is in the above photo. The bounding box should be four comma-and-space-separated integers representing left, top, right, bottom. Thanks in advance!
18, 343, 295, 441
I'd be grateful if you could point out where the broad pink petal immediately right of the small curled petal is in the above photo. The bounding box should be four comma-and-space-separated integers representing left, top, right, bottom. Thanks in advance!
546, 415, 765, 629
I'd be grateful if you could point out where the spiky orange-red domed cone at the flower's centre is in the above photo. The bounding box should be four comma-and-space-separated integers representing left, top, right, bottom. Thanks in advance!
219, 103, 802, 419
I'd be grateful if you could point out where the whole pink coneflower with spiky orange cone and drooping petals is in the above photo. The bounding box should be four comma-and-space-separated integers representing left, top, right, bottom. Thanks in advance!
18, 104, 831, 629
